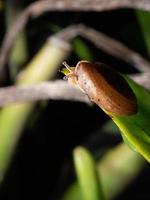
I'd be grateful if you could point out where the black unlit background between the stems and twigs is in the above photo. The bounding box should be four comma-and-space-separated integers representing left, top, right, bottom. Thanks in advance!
0, 5, 150, 200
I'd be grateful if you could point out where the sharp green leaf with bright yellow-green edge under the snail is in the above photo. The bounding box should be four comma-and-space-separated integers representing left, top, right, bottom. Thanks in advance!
111, 76, 150, 162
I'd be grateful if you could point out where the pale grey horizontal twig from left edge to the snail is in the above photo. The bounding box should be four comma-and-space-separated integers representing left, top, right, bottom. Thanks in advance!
0, 81, 91, 106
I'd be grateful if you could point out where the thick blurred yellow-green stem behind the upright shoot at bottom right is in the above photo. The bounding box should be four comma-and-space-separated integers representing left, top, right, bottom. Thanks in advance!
62, 143, 146, 200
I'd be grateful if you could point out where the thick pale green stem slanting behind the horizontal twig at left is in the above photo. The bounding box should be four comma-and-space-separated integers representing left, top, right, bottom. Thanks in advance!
0, 39, 69, 180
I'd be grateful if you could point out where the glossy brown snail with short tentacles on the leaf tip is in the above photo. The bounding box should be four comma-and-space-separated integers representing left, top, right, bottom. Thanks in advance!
63, 60, 137, 116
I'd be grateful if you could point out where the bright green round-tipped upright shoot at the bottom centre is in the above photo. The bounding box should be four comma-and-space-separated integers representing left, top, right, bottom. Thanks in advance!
74, 147, 104, 200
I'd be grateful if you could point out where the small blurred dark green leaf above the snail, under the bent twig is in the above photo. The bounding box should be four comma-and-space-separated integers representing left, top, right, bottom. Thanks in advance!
73, 38, 93, 61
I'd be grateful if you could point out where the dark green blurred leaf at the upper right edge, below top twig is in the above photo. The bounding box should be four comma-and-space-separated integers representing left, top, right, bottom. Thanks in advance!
136, 10, 150, 55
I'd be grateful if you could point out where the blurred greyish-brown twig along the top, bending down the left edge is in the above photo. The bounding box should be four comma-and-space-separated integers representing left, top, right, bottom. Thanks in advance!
0, 0, 150, 76
